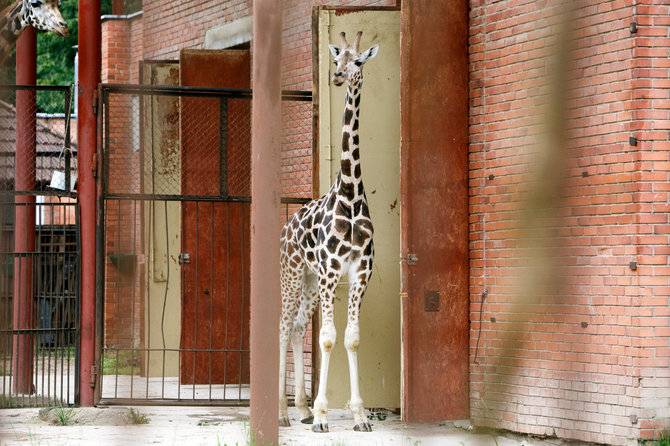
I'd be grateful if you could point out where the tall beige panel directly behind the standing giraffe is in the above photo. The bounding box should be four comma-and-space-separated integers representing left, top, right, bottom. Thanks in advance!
319, 11, 400, 407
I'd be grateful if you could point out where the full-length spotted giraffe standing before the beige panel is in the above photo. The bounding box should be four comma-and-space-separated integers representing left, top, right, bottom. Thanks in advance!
279, 31, 379, 432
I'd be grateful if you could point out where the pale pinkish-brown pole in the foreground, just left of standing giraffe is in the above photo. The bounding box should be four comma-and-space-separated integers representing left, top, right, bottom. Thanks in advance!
250, 0, 283, 444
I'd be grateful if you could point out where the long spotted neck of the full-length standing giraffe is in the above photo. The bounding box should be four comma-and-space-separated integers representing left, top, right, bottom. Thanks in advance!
338, 81, 364, 202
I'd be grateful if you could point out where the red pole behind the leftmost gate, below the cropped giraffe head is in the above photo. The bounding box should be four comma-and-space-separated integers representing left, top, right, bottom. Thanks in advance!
12, 26, 37, 394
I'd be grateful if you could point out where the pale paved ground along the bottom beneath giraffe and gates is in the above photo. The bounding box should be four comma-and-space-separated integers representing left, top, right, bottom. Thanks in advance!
0, 406, 596, 446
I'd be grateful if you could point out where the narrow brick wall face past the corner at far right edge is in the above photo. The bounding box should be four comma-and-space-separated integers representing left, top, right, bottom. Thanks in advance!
631, 0, 670, 439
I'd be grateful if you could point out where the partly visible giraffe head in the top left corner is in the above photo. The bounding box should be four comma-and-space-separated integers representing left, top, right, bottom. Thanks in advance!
0, 0, 70, 66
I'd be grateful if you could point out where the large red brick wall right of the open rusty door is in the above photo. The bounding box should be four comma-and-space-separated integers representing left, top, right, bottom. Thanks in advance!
470, 0, 670, 444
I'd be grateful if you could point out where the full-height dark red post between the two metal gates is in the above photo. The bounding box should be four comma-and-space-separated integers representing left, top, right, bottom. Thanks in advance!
77, 0, 100, 406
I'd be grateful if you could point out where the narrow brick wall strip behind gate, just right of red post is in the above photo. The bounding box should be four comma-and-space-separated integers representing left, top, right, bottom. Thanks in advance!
101, 15, 143, 349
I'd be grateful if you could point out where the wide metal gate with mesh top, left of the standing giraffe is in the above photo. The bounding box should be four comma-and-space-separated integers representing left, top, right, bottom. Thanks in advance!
97, 85, 312, 405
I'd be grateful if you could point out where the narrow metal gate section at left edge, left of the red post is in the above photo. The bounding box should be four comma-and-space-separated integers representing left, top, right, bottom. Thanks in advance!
0, 86, 80, 408
